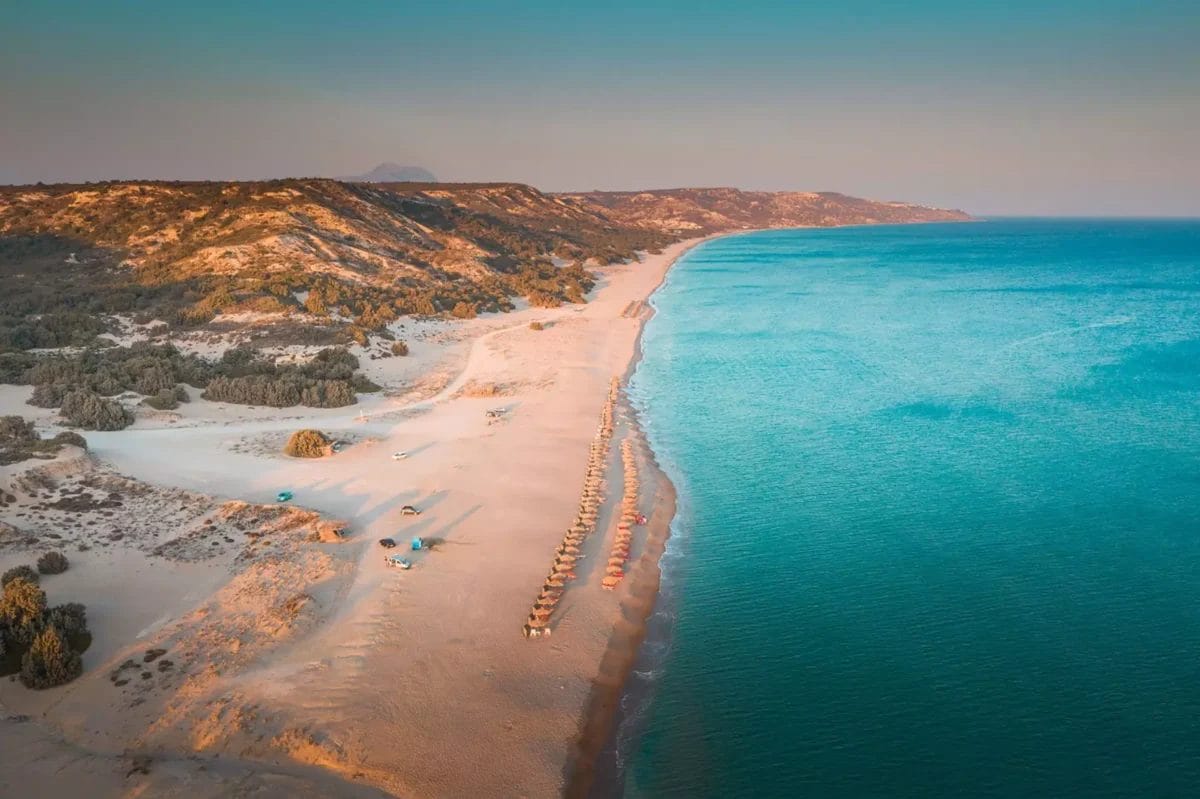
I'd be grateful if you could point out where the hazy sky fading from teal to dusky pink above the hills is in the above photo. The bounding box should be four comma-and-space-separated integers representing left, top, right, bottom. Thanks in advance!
0, 0, 1200, 216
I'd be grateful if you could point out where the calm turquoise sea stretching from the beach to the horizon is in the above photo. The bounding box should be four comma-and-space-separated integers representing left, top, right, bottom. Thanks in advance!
607, 220, 1200, 798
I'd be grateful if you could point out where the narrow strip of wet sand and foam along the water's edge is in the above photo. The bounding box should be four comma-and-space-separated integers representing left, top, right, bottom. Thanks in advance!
563, 234, 710, 799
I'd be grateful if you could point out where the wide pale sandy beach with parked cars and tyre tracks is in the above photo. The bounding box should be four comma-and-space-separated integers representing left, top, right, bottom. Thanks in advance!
0, 241, 695, 797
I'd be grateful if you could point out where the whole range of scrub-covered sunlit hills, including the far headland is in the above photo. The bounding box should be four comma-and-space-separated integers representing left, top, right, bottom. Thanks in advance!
0, 179, 967, 350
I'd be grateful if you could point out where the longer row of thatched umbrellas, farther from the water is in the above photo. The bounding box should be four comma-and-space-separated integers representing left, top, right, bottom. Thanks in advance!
521, 378, 620, 638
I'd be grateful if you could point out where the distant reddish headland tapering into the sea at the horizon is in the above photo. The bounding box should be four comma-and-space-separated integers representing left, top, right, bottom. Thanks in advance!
570, 188, 971, 236
